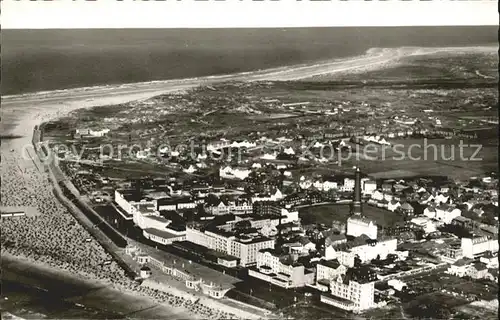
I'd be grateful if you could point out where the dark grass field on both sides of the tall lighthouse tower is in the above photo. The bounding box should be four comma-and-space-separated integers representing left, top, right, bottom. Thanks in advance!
299, 204, 403, 227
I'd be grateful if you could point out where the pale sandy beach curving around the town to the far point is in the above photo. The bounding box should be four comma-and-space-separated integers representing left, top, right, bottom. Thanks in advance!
0, 47, 497, 318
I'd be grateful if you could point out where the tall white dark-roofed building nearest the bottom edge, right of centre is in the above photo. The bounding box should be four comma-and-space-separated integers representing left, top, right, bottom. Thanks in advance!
321, 268, 377, 312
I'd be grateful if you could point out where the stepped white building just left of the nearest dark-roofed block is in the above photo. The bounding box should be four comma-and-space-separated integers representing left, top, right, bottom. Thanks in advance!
248, 249, 314, 289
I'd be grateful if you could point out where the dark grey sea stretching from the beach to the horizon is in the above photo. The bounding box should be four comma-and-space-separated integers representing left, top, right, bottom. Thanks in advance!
0, 26, 498, 95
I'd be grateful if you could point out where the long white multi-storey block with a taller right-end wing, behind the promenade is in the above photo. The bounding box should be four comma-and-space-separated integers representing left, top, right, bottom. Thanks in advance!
186, 227, 274, 267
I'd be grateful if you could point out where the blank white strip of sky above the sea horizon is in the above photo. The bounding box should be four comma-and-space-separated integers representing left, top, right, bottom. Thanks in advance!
1, 0, 499, 29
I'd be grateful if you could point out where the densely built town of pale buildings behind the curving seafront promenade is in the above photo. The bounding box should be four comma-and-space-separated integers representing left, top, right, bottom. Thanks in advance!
8, 76, 498, 318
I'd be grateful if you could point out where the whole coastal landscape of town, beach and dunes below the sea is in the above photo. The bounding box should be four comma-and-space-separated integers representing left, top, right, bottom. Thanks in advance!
0, 2, 499, 320
